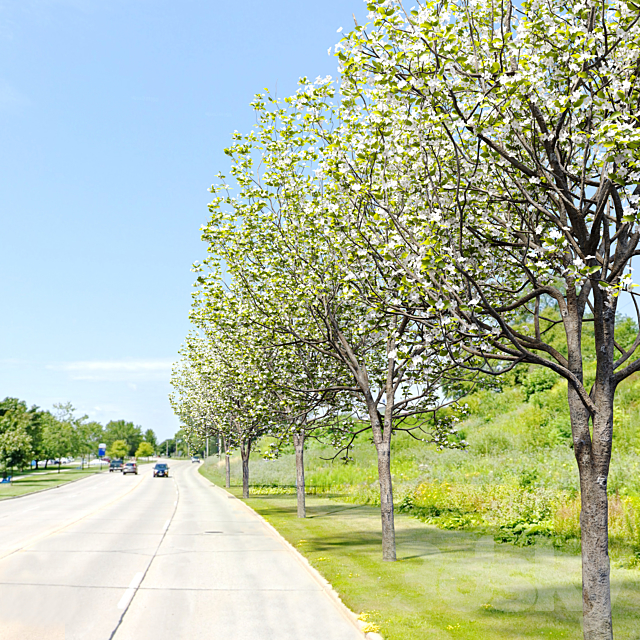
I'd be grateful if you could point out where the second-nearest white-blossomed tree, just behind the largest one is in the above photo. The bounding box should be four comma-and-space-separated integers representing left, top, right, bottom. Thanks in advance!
200, 89, 468, 560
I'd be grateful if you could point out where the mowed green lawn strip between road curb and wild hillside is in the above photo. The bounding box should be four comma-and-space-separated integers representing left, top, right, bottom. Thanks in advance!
202, 467, 640, 640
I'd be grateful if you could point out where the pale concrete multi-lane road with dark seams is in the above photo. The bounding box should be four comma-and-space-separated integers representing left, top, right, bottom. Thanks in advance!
0, 462, 363, 640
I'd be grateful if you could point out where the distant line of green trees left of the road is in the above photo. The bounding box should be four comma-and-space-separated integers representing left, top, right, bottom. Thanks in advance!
0, 398, 158, 476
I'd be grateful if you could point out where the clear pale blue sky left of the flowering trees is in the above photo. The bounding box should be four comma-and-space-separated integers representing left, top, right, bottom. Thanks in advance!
0, 0, 366, 438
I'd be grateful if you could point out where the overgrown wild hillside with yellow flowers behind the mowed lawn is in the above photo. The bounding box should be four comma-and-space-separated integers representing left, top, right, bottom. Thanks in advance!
202, 368, 640, 567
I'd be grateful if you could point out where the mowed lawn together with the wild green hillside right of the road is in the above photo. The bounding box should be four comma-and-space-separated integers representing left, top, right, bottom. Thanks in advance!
201, 368, 640, 640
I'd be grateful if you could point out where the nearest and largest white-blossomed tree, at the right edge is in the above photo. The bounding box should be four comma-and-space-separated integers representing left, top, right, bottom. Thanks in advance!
338, 0, 640, 640
